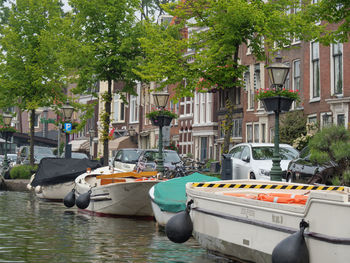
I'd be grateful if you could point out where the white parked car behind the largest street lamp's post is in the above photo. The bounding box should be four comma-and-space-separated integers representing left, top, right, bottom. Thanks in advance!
229, 143, 299, 180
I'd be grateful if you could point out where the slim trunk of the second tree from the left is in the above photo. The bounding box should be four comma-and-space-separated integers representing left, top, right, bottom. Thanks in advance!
103, 79, 112, 166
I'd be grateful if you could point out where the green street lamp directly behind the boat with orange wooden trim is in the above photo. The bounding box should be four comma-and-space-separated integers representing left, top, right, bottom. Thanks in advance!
153, 92, 169, 175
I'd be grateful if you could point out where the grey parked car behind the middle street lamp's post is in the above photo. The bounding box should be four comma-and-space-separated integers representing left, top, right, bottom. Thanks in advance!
136, 149, 181, 172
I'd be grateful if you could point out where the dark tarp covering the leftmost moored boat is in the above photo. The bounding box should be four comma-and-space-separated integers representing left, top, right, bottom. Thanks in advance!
31, 158, 101, 187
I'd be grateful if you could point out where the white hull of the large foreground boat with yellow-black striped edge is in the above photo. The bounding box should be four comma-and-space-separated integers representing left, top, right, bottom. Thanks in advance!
186, 181, 350, 263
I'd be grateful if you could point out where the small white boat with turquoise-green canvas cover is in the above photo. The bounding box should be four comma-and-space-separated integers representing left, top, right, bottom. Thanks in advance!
149, 173, 218, 226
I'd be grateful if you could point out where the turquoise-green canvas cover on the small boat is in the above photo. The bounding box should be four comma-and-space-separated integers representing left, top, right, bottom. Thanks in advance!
153, 173, 220, 213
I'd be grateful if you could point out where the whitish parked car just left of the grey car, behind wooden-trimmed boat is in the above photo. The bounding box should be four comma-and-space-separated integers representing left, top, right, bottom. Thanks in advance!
113, 148, 142, 172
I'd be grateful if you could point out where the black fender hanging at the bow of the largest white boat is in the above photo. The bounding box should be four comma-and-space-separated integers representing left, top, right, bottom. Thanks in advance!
165, 200, 193, 243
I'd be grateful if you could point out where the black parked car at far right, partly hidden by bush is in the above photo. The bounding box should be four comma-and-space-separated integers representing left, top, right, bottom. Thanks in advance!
287, 147, 337, 184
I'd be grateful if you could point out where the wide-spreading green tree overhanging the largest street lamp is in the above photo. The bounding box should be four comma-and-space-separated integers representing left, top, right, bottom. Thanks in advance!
139, 0, 319, 152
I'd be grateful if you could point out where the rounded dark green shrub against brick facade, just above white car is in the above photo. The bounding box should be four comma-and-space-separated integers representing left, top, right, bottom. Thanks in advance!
280, 111, 307, 147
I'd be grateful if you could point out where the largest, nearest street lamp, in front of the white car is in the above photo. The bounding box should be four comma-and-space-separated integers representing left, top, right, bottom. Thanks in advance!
267, 54, 289, 181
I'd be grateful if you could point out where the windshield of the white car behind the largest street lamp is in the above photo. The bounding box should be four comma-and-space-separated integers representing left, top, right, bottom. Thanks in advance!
252, 146, 299, 160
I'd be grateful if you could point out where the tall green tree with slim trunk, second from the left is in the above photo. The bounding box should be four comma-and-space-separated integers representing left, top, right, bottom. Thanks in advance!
70, 0, 142, 165
